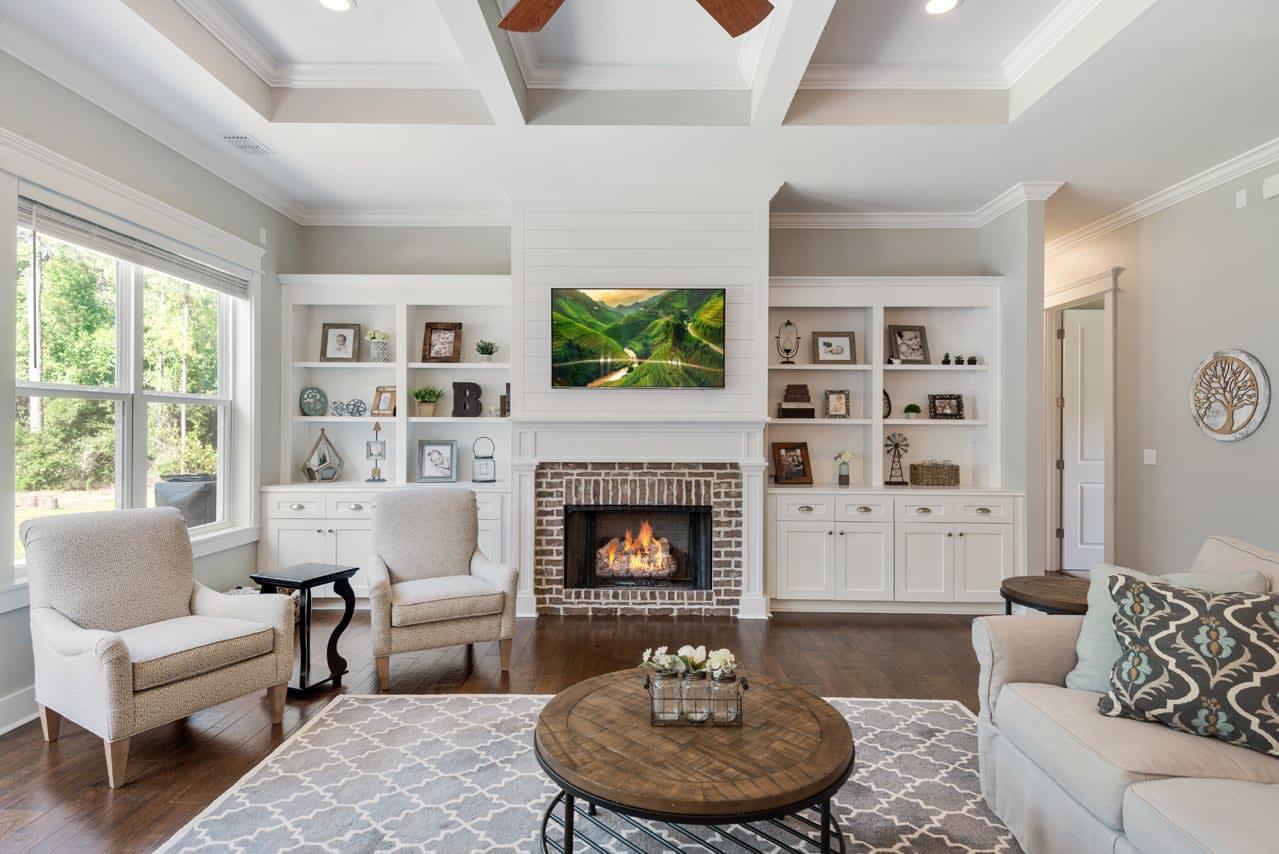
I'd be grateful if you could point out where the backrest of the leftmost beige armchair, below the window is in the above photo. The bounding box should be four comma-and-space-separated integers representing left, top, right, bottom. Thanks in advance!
20, 508, 194, 632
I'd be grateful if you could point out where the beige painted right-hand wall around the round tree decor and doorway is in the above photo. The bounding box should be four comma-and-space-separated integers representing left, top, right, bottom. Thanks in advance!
1048, 166, 1279, 573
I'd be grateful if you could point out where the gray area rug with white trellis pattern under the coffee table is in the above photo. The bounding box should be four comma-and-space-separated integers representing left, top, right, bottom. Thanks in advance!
160, 694, 1021, 854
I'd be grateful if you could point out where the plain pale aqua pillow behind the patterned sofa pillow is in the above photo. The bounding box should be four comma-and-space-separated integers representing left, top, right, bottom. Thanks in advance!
1065, 564, 1270, 694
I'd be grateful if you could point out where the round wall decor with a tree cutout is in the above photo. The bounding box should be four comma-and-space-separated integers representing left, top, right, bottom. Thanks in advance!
1191, 350, 1270, 442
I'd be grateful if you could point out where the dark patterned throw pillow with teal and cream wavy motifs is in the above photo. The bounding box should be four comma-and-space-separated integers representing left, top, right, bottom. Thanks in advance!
1097, 575, 1279, 756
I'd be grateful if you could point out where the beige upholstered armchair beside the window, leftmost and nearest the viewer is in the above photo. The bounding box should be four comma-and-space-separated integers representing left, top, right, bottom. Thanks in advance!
20, 508, 293, 789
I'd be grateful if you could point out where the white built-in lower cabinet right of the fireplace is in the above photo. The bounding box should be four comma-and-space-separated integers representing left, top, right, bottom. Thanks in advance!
769, 490, 1021, 610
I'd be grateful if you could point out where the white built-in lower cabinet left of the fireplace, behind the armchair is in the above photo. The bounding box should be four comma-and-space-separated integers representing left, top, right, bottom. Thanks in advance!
258, 483, 510, 596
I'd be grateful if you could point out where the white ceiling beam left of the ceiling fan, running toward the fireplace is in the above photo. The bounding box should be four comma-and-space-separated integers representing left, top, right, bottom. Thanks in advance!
436, 0, 528, 127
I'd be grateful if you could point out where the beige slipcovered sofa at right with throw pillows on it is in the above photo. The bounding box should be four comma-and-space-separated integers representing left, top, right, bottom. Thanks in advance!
972, 537, 1279, 854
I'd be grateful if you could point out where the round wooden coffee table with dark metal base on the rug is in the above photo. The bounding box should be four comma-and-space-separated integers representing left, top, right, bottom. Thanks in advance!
533, 669, 853, 854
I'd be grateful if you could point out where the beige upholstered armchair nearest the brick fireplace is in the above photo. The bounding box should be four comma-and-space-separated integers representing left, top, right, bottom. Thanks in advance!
368, 488, 518, 690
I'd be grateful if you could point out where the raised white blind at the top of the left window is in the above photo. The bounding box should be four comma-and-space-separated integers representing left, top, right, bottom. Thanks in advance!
18, 196, 249, 299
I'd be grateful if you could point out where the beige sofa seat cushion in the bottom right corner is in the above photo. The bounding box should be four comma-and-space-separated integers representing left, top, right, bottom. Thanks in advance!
1123, 779, 1279, 854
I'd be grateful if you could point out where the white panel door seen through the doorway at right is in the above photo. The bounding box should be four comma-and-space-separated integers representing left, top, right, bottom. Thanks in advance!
1062, 308, 1106, 569
